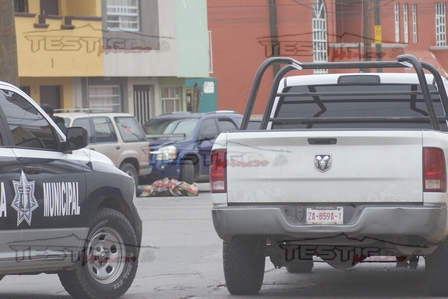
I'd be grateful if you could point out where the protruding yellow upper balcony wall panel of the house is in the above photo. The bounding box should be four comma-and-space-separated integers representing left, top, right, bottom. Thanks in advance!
15, 13, 104, 77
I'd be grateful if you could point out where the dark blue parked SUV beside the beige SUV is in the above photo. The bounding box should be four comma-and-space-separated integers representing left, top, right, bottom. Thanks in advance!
143, 110, 243, 184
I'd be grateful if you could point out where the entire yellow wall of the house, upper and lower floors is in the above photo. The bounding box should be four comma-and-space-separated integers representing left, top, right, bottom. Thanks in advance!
15, 0, 104, 108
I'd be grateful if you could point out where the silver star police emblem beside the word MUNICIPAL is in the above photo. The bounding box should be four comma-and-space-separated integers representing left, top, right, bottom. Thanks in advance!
11, 171, 39, 226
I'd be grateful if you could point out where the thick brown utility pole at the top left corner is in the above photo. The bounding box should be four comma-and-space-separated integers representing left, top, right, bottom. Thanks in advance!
0, 0, 19, 86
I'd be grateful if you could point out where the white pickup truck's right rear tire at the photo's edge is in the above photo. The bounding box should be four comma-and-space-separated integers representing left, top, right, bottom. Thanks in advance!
425, 240, 448, 296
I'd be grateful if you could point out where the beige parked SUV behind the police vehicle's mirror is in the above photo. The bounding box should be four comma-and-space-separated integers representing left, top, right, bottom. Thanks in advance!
54, 109, 151, 185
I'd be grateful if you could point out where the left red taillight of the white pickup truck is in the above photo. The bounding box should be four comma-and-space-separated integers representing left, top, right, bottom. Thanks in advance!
210, 149, 227, 193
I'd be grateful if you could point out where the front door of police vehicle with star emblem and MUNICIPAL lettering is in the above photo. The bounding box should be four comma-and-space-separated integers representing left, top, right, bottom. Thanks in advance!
0, 86, 88, 269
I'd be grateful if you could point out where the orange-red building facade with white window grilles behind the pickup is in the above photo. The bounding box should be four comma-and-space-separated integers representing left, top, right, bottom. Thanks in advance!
207, 0, 448, 114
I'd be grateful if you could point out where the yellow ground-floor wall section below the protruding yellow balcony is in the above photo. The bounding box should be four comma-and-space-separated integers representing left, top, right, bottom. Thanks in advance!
20, 77, 73, 108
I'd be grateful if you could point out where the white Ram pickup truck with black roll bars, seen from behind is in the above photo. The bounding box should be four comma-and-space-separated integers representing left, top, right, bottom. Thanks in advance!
210, 55, 448, 296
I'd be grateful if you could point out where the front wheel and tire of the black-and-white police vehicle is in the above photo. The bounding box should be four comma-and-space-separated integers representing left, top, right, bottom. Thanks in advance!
58, 208, 138, 299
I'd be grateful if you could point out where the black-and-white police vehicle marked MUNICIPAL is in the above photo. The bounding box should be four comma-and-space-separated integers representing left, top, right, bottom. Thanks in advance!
0, 82, 142, 298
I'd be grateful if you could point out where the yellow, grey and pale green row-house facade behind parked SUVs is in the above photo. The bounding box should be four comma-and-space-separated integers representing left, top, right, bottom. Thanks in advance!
14, 0, 212, 123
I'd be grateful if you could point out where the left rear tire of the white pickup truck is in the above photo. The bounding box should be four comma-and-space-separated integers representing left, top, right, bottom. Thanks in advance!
223, 236, 266, 295
